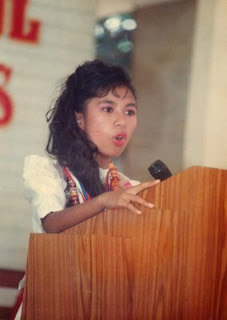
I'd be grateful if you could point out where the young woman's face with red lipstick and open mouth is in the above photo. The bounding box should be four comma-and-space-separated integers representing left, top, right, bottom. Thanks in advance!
76, 87, 137, 168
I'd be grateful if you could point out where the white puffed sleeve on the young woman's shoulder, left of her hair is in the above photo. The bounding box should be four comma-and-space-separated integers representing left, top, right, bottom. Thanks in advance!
23, 155, 66, 232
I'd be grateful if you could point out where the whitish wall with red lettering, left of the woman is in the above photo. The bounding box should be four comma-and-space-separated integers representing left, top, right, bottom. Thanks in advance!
0, 0, 95, 310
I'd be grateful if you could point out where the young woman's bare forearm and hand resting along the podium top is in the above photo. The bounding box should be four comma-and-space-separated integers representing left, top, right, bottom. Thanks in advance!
42, 180, 160, 233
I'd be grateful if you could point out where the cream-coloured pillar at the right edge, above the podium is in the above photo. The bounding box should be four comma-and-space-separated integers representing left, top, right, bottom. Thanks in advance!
184, 0, 227, 169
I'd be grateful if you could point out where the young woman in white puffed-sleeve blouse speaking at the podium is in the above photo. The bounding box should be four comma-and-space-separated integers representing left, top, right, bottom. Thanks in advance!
24, 60, 158, 232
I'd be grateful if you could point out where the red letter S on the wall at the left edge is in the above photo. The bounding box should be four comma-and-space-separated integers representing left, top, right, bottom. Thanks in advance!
0, 64, 13, 127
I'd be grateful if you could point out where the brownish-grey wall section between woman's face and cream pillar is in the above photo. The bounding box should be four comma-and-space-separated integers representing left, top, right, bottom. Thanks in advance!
124, 0, 196, 181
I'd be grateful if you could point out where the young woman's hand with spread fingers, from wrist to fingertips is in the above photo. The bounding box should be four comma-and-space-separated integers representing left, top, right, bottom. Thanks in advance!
99, 180, 160, 214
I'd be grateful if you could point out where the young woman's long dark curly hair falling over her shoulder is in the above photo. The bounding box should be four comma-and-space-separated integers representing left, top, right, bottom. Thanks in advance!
46, 60, 135, 197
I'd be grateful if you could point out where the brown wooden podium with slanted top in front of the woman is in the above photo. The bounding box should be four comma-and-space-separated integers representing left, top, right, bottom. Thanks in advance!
22, 167, 227, 320
